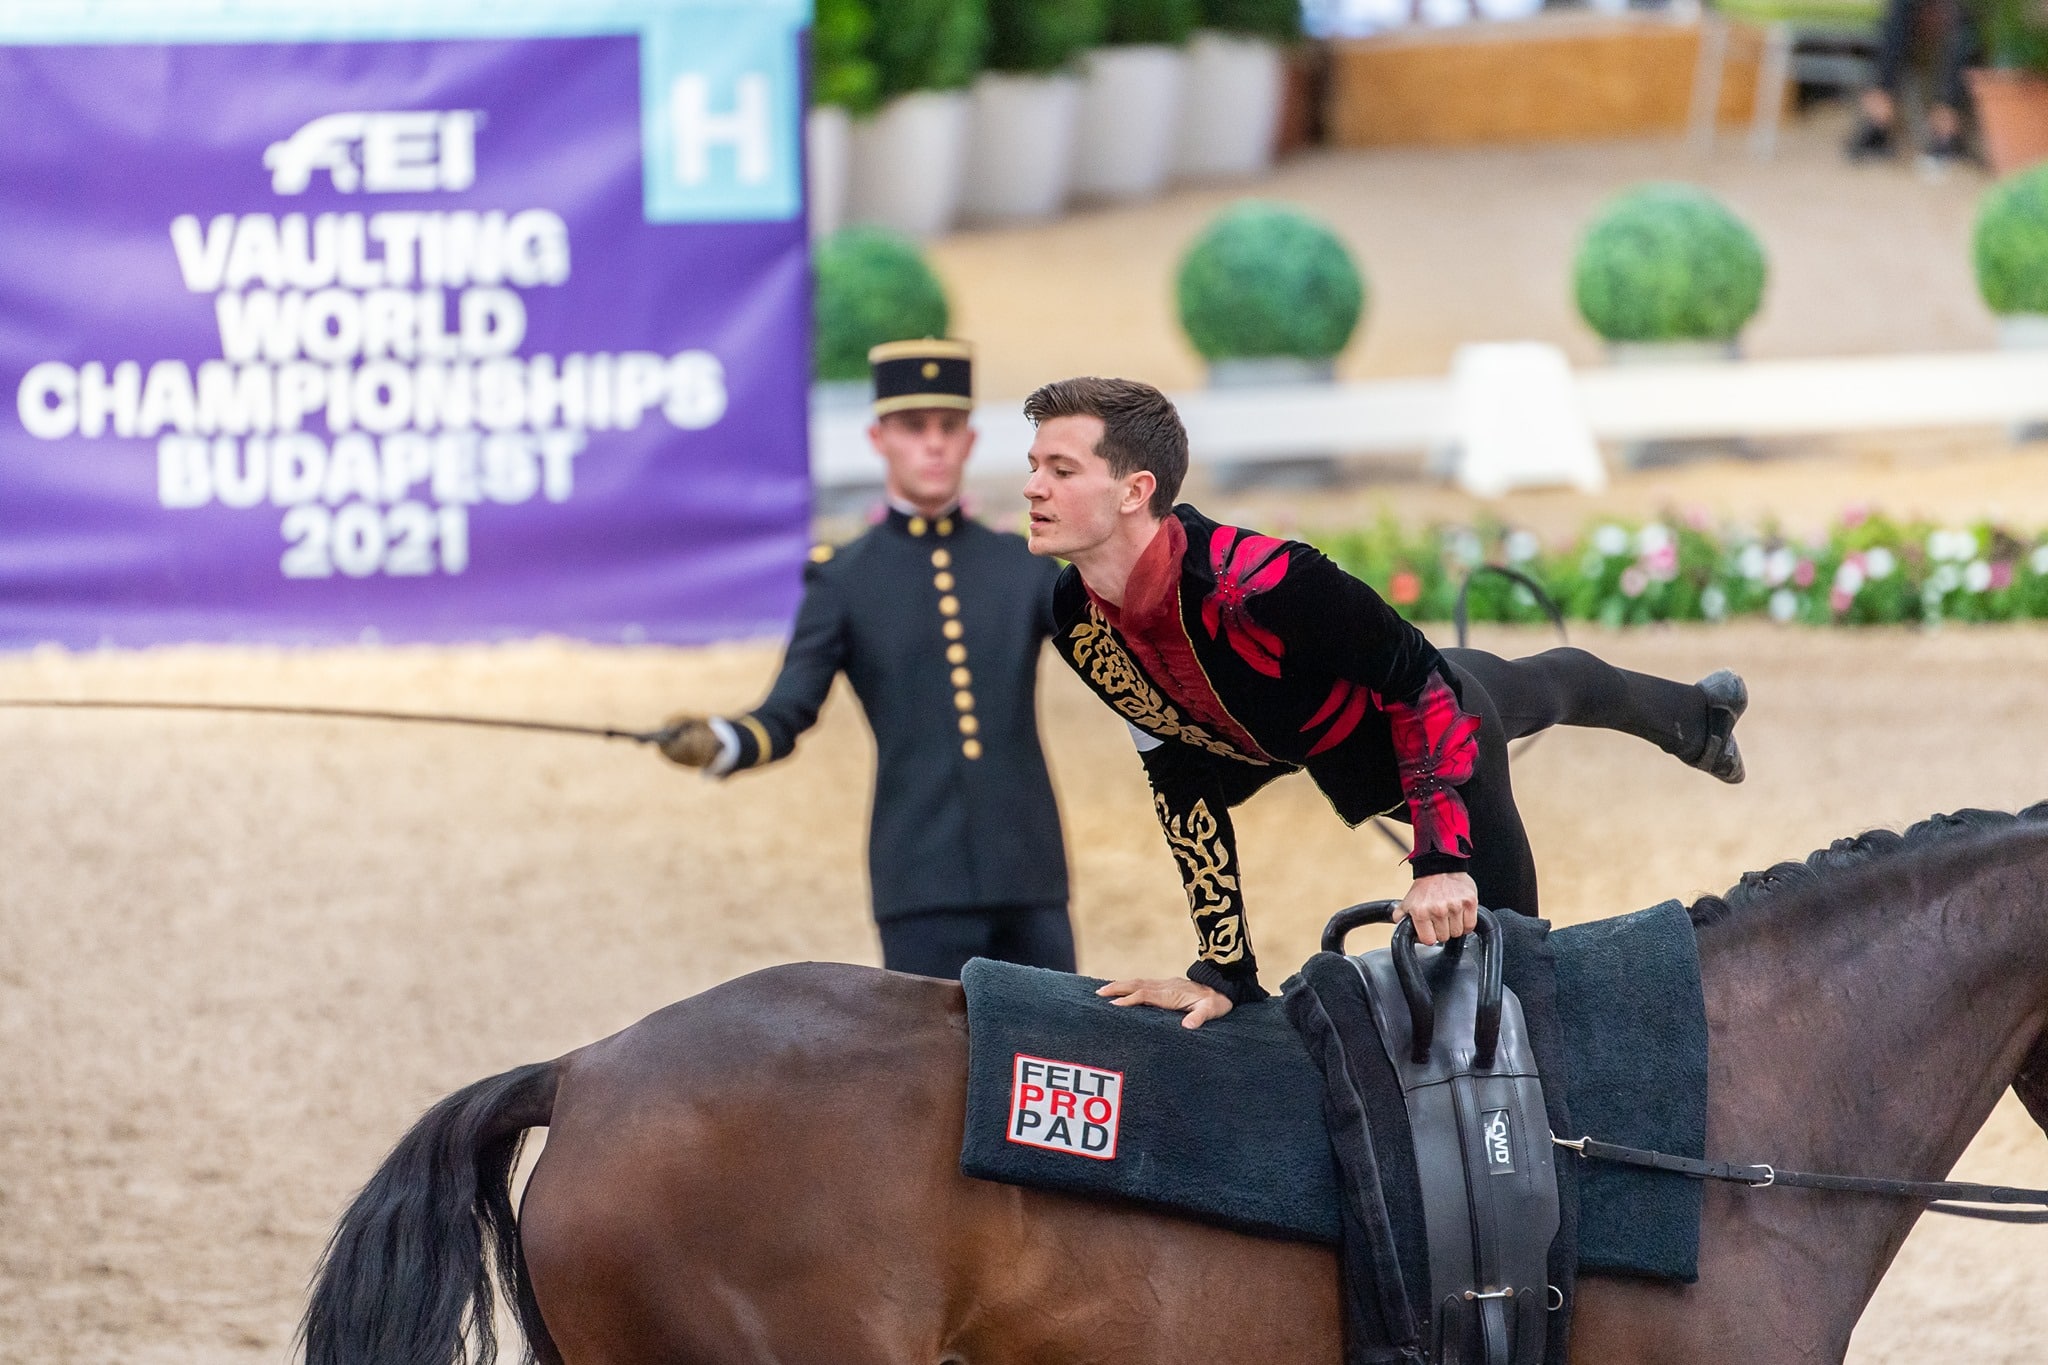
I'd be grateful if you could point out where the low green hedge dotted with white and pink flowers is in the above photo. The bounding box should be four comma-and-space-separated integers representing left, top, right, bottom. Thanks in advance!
1309, 514, 2048, 626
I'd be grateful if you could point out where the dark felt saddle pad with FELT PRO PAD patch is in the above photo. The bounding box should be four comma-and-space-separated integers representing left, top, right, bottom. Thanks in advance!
961, 900, 1706, 1281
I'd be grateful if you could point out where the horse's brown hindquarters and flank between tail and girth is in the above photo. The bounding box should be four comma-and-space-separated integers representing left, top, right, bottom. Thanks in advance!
520, 964, 1337, 1365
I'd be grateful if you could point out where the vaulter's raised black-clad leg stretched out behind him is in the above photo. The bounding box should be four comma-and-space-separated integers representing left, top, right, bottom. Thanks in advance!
1444, 647, 1749, 782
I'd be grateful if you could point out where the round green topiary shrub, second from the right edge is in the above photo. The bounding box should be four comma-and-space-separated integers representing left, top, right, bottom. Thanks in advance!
1573, 184, 1765, 342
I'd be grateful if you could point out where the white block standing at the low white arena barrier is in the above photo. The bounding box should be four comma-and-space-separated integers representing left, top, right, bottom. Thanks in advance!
1450, 342, 1608, 497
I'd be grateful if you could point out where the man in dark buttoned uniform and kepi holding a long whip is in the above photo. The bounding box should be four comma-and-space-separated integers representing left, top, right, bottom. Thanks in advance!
664, 342, 1073, 976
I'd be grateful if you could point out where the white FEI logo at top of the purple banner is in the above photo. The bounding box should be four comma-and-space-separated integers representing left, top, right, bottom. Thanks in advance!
262, 108, 483, 194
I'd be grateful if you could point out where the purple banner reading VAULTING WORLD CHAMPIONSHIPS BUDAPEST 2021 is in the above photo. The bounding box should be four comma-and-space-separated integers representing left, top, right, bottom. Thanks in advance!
0, 35, 809, 647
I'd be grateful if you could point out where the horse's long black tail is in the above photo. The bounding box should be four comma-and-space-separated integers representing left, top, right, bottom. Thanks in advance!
299, 1062, 559, 1365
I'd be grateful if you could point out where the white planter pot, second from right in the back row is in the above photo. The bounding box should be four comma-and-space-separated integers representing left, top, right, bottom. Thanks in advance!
1073, 43, 1188, 201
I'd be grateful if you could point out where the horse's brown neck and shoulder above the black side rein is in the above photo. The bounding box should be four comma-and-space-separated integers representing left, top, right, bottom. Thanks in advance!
1700, 833, 2048, 1177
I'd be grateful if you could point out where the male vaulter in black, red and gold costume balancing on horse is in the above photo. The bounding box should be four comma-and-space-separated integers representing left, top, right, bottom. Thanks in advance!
1024, 379, 1749, 1027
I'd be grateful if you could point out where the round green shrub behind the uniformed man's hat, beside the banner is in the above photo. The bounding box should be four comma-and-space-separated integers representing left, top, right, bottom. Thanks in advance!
811, 227, 946, 381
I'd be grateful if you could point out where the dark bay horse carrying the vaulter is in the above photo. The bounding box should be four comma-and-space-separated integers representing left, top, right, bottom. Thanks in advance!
305, 802, 2048, 1365
